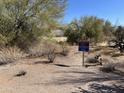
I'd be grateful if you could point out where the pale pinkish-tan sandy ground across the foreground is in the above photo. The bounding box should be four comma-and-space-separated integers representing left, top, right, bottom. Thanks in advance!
0, 47, 124, 93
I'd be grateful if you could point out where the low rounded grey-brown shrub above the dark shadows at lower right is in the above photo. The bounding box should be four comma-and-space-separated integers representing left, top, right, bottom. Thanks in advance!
100, 63, 115, 73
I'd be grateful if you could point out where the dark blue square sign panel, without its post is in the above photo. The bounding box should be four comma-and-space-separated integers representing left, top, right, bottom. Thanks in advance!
78, 41, 89, 52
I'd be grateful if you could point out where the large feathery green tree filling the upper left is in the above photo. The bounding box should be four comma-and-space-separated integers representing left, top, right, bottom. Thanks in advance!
0, 0, 66, 49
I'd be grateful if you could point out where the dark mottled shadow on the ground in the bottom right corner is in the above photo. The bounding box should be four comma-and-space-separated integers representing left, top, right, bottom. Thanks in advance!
72, 83, 124, 93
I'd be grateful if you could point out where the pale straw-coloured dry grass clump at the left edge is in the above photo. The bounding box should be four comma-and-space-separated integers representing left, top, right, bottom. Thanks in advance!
0, 47, 27, 64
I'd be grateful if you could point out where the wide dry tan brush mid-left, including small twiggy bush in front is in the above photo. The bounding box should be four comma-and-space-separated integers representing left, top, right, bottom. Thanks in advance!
29, 40, 68, 63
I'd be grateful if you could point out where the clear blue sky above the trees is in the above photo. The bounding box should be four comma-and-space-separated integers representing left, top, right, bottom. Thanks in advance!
63, 0, 124, 25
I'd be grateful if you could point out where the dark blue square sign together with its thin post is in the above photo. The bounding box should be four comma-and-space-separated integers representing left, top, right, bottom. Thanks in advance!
78, 41, 89, 66
